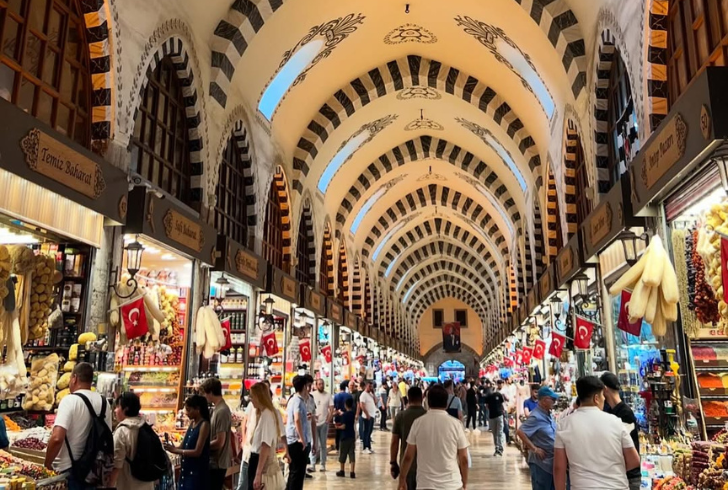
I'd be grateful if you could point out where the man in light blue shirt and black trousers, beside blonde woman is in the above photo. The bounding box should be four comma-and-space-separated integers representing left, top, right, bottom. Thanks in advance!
286, 376, 315, 490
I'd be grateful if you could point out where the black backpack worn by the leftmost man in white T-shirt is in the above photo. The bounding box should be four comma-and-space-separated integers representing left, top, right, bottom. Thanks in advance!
66, 393, 114, 486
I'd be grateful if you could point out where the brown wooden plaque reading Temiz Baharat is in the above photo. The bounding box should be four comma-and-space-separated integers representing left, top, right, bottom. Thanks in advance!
20, 129, 106, 199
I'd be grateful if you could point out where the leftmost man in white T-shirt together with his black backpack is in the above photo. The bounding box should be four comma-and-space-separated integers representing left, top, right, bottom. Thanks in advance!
45, 362, 114, 490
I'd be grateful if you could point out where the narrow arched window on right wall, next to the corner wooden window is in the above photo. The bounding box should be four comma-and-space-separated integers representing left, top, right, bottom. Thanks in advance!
607, 47, 634, 188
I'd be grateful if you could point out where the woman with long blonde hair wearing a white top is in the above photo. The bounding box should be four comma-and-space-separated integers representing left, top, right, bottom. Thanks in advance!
247, 383, 286, 490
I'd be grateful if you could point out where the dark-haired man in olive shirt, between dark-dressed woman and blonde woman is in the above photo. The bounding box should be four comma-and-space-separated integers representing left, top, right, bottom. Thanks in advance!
200, 378, 233, 490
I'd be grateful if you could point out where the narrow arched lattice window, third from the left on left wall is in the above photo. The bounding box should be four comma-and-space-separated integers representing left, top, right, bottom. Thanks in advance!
215, 137, 250, 247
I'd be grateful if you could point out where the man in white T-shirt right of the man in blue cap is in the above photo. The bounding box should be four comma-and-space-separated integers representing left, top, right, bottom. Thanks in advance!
554, 376, 640, 490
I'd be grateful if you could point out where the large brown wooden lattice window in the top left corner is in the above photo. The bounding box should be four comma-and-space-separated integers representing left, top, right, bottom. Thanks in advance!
0, 0, 91, 148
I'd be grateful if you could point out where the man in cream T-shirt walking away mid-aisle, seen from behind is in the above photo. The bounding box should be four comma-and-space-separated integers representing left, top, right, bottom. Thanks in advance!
399, 385, 468, 490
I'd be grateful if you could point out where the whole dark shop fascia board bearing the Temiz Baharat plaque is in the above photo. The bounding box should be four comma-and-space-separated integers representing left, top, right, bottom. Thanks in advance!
0, 99, 128, 224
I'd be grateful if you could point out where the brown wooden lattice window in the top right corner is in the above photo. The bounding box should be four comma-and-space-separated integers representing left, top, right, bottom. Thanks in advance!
667, 0, 728, 104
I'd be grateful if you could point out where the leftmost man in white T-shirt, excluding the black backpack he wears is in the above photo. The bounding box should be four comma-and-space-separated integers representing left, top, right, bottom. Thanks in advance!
45, 362, 111, 490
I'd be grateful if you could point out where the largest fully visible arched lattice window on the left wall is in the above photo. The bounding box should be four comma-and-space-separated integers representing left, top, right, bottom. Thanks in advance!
131, 57, 192, 203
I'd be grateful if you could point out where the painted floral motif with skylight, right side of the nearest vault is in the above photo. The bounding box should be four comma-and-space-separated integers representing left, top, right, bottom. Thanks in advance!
455, 15, 554, 119
